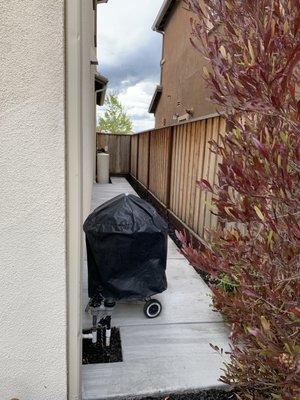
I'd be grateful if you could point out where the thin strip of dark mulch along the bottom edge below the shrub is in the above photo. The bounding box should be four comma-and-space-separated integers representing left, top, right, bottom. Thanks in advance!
130, 389, 236, 400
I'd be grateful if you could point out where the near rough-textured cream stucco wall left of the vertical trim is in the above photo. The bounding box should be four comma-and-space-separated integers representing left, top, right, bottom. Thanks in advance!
0, 0, 67, 400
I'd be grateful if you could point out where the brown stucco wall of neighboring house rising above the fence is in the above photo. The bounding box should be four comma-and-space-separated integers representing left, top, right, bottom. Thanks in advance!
155, 0, 215, 128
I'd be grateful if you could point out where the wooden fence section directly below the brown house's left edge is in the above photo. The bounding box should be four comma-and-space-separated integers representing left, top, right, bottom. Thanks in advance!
149, 128, 170, 204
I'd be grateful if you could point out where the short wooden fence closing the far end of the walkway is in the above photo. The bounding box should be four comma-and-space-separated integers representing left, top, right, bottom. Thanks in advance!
97, 132, 131, 175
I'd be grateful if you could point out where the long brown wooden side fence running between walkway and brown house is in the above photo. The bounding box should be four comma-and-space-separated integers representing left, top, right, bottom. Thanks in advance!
130, 116, 225, 239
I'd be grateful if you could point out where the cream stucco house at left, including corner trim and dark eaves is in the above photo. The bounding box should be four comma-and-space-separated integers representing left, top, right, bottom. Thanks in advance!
0, 0, 107, 400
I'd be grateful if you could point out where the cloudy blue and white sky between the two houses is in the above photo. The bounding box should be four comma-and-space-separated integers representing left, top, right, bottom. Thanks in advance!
97, 0, 163, 132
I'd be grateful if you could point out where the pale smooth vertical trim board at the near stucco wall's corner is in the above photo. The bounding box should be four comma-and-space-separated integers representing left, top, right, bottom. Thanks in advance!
65, 0, 82, 400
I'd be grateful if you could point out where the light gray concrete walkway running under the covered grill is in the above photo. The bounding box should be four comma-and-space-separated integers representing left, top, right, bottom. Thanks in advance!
82, 178, 228, 400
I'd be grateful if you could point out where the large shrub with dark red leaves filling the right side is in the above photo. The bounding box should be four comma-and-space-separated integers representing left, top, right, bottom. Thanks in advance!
181, 0, 300, 400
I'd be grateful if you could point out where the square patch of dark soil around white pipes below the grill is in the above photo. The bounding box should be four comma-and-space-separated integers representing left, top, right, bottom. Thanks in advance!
82, 328, 123, 364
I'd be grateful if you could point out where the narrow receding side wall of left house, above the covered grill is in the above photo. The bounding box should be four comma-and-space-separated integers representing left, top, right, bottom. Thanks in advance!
82, 0, 97, 219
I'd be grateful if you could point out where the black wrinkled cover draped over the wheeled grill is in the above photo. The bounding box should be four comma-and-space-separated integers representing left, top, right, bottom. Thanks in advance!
83, 194, 167, 300
